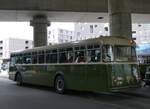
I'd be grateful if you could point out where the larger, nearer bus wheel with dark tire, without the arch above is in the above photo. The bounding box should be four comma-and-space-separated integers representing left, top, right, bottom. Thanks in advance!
55, 75, 65, 94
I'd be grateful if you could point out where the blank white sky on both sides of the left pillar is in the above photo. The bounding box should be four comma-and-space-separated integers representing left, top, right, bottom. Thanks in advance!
0, 22, 74, 40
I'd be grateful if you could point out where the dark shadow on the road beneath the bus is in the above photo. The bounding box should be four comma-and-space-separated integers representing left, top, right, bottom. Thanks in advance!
10, 80, 150, 102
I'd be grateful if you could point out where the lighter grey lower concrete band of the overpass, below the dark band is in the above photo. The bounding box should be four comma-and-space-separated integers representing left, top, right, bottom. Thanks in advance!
0, 10, 150, 23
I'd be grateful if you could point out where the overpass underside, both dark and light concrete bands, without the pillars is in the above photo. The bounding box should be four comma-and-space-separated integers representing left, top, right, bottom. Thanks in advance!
0, 0, 150, 23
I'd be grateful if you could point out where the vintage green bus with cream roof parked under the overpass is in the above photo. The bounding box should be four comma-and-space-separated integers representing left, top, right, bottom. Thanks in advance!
9, 36, 139, 93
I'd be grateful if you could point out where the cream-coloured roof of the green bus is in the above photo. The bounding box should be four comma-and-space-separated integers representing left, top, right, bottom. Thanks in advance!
13, 36, 135, 54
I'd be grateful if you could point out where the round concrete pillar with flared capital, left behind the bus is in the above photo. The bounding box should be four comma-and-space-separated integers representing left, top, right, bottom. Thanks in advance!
30, 15, 50, 47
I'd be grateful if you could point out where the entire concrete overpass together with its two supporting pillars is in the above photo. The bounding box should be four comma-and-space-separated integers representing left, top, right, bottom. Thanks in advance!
0, 0, 150, 46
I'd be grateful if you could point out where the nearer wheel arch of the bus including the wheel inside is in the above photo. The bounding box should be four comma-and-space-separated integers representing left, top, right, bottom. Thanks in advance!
54, 72, 65, 94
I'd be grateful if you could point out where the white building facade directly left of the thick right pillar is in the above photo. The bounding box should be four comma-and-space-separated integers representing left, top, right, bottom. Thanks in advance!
74, 23, 109, 41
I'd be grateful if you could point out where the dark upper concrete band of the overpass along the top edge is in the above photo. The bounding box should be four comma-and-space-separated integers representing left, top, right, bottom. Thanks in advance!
0, 0, 150, 13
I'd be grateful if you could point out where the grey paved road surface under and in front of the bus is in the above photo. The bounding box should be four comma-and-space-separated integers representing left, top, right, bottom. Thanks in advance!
0, 78, 150, 109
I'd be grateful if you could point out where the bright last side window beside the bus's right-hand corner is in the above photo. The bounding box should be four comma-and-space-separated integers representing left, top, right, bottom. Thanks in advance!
102, 45, 113, 62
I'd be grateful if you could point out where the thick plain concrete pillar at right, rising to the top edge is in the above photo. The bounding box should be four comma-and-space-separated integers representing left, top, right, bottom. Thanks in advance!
108, 0, 132, 38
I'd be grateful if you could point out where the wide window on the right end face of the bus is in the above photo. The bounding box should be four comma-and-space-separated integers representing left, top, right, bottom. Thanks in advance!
114, 46, 136, 61
